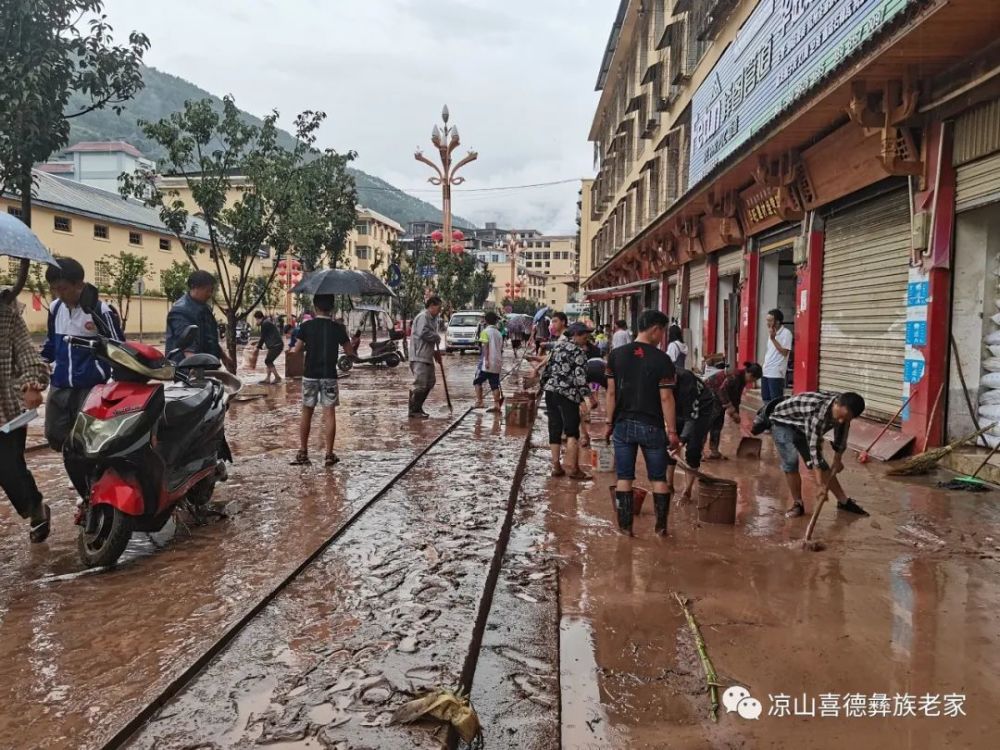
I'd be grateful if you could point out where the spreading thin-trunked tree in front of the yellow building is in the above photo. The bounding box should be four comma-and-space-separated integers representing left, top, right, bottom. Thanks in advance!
121, 97, 334, 362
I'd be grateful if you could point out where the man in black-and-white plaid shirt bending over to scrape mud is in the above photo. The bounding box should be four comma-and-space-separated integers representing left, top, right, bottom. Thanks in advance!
771, 391, 868, 518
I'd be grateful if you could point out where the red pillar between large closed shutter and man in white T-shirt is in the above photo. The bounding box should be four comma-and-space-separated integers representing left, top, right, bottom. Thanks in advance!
795, 228, 824, 393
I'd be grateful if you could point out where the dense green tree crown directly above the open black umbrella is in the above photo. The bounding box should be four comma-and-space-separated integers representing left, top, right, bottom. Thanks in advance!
289, 151, 358, 272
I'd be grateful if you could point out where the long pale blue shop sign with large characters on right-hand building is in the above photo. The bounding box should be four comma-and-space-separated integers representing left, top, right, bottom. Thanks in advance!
686, 0, 919, 187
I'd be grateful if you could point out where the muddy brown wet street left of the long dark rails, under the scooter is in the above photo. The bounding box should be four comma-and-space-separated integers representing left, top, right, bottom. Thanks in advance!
0, 357, 488, 750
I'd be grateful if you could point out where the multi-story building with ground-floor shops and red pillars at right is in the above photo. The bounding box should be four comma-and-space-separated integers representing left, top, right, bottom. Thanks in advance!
584, 0, 1000, 450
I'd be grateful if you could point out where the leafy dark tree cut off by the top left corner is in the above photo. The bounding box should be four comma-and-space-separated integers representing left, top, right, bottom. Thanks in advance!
0, 0, 149, 232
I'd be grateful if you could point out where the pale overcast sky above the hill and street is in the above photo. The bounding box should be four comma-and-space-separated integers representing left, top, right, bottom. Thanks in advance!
105, 0, 618, 233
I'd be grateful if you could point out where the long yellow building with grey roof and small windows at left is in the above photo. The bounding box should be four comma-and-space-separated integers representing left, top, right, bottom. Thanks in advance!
0, 170, 208, 333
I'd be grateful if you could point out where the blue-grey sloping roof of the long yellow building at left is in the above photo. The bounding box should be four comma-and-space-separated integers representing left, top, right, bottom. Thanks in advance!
24, 169, 208, 242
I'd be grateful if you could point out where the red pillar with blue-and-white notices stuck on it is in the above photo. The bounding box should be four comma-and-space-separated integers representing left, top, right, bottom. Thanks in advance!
903, 123, 955, 452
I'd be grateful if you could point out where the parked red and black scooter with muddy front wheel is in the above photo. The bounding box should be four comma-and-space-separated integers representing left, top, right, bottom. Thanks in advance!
63, 315, 240, 567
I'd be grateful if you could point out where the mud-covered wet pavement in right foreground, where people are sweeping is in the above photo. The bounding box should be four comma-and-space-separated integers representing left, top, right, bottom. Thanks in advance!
548, 412, 1000, 750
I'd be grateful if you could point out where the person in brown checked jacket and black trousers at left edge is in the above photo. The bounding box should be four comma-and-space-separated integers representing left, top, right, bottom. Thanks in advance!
0, 301, 52, 544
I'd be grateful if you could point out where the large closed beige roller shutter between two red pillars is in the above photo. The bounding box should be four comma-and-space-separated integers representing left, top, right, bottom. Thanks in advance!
819, 190, 910, 419
